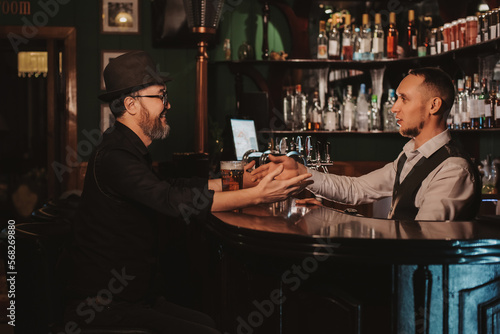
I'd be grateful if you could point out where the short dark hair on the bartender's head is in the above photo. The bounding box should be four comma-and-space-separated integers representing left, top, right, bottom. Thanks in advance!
408, 67, 455, 116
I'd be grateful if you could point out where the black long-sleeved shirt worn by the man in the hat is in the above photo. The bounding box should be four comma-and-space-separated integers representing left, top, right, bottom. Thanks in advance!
70, 122, 213, 301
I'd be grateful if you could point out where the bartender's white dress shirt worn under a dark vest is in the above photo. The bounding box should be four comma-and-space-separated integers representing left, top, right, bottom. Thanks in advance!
308, 130, 474, 220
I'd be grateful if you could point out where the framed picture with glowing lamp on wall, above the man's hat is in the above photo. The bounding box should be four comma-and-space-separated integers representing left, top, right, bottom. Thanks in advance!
101, 0, 140, 34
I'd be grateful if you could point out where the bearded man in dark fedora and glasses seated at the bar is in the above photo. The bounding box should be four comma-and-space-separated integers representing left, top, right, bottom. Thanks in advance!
67, 51, 310, 333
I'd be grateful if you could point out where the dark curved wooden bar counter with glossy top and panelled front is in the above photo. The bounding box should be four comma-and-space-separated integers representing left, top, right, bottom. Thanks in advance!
206, 199, 500, 333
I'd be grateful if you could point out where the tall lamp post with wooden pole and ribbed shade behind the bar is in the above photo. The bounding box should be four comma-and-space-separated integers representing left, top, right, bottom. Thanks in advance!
184, 0, 224, 153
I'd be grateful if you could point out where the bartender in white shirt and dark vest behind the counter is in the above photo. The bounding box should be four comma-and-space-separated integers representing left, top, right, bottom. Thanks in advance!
252, 68, 481, 220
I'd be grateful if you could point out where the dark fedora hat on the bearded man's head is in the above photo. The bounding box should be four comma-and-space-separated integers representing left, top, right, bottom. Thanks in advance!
99, 51, 172, 102
